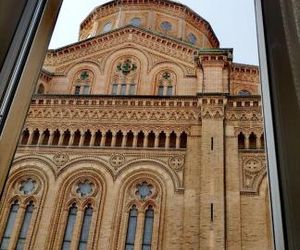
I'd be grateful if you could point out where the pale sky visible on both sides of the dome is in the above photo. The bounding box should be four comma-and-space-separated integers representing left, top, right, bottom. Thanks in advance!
50, 0, 258, 64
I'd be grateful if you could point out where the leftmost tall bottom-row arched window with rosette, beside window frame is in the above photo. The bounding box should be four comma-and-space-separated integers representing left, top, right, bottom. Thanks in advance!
0, 174, 47, 250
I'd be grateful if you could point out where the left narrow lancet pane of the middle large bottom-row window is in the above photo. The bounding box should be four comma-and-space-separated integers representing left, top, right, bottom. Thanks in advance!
61, 203, 78, 250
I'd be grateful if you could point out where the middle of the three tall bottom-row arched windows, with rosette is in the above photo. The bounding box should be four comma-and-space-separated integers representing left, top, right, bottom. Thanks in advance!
47, 176, 103, 250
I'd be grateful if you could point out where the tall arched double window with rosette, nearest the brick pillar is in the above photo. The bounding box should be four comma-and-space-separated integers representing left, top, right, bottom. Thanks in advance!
115, 179, 163, 250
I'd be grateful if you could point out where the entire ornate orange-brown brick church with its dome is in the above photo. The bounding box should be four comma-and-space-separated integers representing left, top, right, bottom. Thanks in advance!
0, 0, 272, 250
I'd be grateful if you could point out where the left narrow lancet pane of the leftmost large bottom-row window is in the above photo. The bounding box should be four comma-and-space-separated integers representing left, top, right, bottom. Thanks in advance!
0, 200, 19, 249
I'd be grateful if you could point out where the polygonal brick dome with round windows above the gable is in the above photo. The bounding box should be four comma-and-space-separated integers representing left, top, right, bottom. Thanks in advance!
79, 0, 219, 48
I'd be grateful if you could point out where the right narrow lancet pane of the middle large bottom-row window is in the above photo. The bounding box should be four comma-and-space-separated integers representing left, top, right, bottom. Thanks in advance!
78, 204, 93, 250
